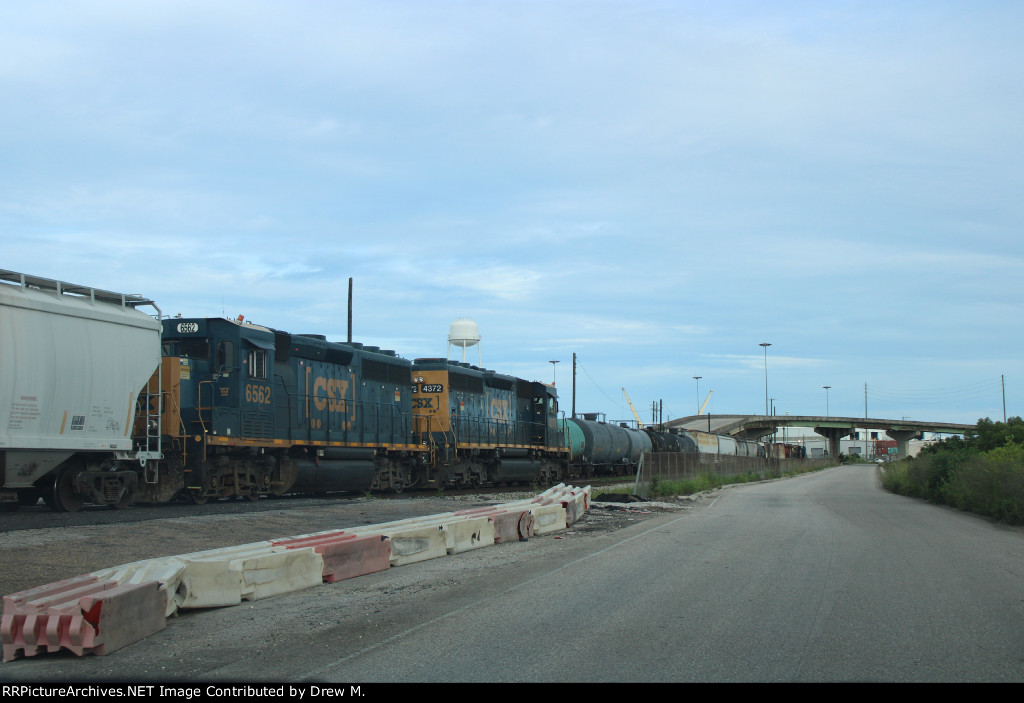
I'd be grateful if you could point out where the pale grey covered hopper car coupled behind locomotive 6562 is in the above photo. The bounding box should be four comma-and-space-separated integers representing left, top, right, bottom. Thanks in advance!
0, 270, 161, 511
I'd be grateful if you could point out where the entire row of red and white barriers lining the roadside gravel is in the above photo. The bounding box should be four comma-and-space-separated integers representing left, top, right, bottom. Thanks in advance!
0, 484, 590, 661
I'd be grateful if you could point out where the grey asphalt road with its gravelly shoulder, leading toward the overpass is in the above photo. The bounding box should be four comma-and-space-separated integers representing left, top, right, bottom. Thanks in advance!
0, 466, 1024, 684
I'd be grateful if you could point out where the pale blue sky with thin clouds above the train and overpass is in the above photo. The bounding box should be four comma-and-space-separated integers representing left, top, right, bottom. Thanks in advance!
0, 0, 1024, 424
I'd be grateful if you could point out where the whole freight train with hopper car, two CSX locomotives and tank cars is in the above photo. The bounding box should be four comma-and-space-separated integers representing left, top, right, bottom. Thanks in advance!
0, 269, 764, 512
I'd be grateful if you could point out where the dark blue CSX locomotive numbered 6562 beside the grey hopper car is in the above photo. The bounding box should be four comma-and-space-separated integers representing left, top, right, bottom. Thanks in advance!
143, 318, 428, 502
